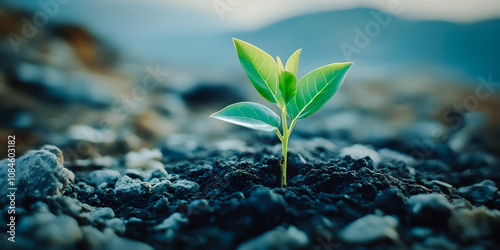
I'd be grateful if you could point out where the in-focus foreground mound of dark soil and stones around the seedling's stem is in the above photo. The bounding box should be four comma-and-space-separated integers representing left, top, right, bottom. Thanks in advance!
1, 130, 500, 249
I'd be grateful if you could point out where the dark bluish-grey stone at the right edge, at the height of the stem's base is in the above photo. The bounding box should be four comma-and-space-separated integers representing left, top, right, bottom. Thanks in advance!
457, 180, 498, 203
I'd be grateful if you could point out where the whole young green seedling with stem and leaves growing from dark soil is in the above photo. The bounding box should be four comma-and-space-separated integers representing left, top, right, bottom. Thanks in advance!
210, 38, 352, 187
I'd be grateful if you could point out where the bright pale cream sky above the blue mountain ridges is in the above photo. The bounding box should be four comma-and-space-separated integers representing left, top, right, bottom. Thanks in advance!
167, 0, 500, 29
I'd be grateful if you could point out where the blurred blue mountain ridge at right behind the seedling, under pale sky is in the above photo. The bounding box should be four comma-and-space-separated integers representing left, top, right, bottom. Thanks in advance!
237, 8, 500, 81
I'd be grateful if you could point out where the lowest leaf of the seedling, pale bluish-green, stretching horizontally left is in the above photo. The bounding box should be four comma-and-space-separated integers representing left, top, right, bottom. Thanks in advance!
210, 102, 280, 131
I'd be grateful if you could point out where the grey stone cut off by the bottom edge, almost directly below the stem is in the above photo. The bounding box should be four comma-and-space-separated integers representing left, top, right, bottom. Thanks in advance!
237, 226, 309, 250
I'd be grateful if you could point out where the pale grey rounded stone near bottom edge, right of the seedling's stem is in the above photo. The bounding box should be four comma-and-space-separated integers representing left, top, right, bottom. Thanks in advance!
339, 214, 399, 245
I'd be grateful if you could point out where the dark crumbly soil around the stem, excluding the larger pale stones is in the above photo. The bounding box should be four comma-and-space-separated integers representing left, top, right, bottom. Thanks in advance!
56, 136, 500, 249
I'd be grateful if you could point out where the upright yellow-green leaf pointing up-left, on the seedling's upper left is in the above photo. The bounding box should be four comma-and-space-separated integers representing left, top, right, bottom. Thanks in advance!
233, 38, 283, 104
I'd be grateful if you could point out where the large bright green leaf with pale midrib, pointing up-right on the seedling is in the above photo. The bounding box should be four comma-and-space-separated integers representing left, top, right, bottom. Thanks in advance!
287, 62, 352, 120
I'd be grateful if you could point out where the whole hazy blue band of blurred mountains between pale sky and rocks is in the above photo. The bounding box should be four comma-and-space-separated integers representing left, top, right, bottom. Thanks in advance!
1, 1, 500, 82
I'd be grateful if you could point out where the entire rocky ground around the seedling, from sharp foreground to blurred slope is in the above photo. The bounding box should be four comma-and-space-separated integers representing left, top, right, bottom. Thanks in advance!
0, 6, 500, 249
